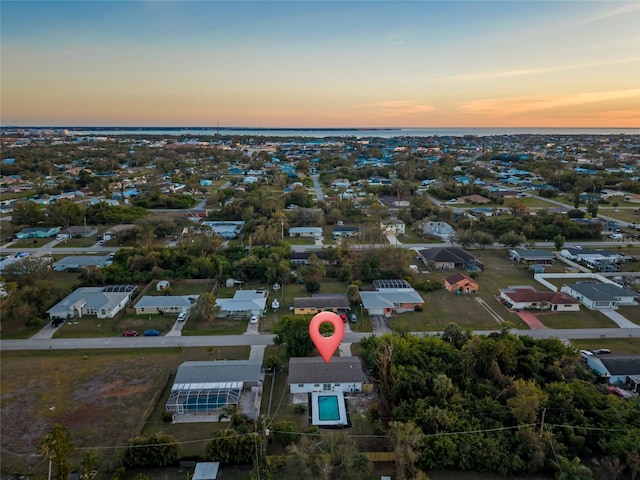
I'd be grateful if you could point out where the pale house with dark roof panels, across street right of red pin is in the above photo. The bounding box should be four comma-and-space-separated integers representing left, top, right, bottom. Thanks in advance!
360, 280, 424, 316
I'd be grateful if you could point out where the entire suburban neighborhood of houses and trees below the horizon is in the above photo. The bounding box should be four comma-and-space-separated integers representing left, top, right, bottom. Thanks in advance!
0, 128, 640, 479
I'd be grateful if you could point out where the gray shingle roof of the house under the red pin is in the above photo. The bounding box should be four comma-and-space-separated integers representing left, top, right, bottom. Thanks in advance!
287, 357, 367, 384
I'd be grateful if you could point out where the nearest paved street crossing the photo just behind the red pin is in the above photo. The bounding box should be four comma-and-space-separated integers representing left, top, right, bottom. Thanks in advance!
0, 328, 640, 351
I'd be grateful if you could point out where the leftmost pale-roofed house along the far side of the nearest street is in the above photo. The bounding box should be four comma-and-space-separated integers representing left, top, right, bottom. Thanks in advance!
47, 285, 136, 320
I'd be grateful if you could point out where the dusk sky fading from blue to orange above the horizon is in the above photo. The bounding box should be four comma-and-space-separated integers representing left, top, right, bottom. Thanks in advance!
0, 0, 640, 128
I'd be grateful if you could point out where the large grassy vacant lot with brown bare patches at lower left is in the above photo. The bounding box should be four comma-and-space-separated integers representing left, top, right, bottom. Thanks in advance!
0, 347, 249, 478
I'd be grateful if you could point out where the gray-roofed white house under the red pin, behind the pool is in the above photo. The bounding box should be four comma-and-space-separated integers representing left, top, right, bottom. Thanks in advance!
287, 357, 367, 395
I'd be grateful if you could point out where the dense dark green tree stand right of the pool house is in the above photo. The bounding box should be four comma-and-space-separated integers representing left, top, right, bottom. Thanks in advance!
361, 324, 640, 476
